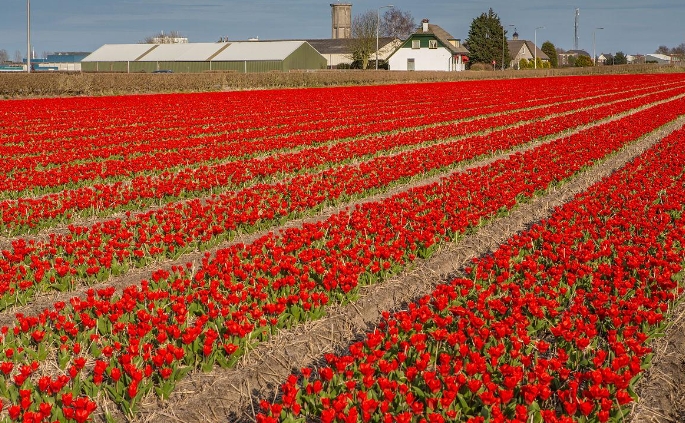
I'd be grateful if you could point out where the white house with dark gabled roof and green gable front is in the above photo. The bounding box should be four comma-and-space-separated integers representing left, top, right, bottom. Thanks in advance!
388, 19, 469, 71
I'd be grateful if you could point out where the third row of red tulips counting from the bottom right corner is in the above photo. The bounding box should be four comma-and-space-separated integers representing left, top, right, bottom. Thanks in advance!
0, 93, 683, 308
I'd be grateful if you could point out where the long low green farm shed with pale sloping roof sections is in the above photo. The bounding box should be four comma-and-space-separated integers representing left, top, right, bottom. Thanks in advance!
81, 41, 326, 72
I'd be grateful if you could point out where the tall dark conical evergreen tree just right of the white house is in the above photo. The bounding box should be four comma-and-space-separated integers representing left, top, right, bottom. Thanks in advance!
466, 8, 511, 68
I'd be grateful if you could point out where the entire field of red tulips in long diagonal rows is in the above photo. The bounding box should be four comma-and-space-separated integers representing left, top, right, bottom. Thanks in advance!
0, 73, 685, 423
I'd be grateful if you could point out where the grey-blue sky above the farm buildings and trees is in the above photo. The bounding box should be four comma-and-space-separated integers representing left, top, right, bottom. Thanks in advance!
0, 0, 685, 58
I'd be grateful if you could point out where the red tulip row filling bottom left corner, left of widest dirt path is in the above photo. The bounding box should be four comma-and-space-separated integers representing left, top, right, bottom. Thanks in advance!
0, 93, 685, 421
